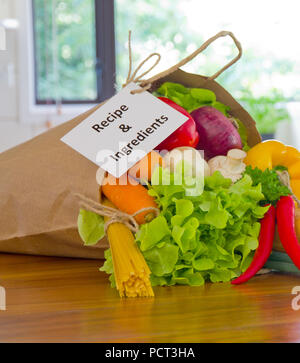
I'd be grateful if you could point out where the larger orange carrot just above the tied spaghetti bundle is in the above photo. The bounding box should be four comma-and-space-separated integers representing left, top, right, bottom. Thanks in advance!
101, 175, 158, 224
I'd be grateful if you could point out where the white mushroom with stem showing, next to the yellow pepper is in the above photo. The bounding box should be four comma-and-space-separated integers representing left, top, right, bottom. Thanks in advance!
208, 149, 247, 182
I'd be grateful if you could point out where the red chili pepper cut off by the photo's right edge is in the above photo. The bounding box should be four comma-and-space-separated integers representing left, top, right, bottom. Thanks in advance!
276, 195, 300, 269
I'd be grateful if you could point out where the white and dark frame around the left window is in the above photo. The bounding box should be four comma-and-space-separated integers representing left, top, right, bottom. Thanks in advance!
16, 0, 116, 124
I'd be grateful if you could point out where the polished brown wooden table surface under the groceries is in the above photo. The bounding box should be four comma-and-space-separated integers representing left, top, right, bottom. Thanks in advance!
0, 255, 300, 343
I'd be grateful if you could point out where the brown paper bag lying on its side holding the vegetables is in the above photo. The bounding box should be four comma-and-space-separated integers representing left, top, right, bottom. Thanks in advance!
0, 34, 261, 259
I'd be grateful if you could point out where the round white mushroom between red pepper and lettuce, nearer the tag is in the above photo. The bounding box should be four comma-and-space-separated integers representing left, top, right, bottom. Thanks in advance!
164, 146, 210, 177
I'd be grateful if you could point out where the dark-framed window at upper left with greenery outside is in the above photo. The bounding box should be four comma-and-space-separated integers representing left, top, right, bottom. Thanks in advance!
32, 0, 115, 105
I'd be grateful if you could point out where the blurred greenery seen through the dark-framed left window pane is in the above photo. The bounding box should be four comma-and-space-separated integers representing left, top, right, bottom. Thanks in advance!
33, 0, 97, 101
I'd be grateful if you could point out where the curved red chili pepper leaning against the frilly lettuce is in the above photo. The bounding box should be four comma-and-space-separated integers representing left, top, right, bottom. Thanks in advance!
231, 205, 276, 285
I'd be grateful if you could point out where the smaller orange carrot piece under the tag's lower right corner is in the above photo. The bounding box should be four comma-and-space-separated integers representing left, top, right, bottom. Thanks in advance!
128, 150, 164, 180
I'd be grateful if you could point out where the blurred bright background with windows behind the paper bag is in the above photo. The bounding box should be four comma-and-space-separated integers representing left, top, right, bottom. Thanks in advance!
0, 0, 300, 152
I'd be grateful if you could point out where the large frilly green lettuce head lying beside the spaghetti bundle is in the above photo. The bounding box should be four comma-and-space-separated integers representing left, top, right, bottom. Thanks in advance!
102, 168, 268, 286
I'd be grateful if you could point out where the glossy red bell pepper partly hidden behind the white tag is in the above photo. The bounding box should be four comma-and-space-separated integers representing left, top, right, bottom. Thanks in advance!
155, 97, 199, 151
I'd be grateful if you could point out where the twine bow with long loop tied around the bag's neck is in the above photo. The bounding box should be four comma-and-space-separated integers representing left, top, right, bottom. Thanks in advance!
123, 30, 243, 94
